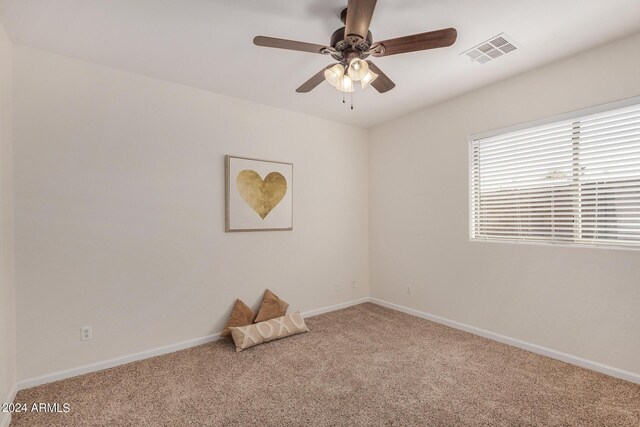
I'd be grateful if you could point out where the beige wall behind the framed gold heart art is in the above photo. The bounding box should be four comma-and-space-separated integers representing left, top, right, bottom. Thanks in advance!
14, 46, 369, 380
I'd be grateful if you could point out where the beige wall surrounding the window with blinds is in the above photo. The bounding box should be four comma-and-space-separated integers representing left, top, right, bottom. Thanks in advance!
369, 35, 640, 373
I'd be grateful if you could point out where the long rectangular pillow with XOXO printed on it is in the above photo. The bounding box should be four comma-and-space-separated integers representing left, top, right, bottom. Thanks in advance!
229, 311, 309, 352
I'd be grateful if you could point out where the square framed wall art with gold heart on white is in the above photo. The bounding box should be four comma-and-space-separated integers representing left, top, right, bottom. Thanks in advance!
225, 156, 293, 231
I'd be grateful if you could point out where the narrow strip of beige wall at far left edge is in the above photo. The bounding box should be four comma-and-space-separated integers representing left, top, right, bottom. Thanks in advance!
0, 17, 16, 425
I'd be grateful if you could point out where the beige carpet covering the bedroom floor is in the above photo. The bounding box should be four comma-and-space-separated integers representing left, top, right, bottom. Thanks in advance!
11, 304, 640, 427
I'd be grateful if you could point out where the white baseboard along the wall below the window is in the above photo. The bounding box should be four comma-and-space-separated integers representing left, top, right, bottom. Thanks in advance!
369, 298, 640, 384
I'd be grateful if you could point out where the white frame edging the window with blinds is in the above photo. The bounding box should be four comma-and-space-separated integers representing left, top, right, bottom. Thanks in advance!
467, 96, 640, 251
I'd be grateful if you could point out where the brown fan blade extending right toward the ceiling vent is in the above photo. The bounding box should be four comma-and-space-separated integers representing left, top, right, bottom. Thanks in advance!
370, 28, 458, 57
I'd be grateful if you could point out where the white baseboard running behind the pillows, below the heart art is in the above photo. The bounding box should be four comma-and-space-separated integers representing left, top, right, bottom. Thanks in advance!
16, 297, 369, 392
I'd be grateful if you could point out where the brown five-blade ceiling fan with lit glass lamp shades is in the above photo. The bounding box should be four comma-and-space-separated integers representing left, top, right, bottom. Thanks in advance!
253, 0, 458, 93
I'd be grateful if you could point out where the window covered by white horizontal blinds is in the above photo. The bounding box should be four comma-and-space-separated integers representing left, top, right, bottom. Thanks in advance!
470, 98, 640, 248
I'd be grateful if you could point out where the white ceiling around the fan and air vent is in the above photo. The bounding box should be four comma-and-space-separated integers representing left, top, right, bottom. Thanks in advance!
0, 0, 640, 127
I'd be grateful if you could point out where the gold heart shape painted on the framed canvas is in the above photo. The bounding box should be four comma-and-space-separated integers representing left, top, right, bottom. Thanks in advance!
236, 169, 287, 219
